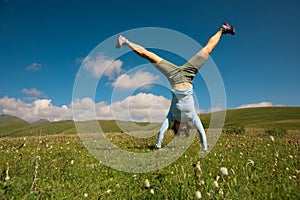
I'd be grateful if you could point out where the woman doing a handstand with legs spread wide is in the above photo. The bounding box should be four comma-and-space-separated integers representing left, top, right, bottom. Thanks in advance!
116, 22, 235, 151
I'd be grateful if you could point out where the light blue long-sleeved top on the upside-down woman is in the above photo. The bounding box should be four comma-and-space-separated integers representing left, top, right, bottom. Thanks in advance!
156, 87, 207, 151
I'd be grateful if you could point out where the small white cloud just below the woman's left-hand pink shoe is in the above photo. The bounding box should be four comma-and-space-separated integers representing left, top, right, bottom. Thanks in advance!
83, 54, 123, 79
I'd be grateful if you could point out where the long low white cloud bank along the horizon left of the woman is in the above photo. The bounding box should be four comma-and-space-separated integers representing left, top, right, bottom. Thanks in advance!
0, 93, 170, 122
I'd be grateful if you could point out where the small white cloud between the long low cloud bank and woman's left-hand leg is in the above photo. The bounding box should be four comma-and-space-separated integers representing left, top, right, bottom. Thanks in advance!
112, 70, 159, 90
